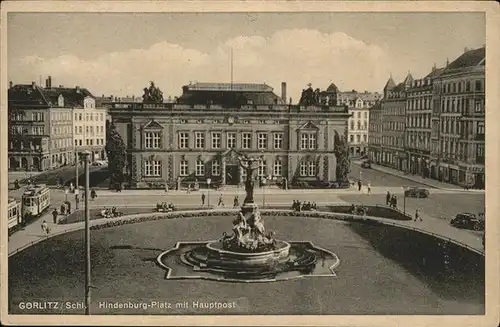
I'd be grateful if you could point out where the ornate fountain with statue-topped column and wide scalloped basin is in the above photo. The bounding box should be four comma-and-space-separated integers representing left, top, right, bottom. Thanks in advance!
158, 157, 339, 281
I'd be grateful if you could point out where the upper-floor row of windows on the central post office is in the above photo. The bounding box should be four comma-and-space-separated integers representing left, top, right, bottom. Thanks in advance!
144, 132, 317, 150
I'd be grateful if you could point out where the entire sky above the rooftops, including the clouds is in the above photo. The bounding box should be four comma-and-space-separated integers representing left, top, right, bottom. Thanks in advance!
7, 12, 486, 102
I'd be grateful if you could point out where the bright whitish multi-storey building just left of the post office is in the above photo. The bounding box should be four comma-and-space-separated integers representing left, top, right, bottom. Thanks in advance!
73, 95, 107, 161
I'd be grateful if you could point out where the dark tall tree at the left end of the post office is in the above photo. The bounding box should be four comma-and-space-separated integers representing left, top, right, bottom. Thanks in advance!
106, 123, 127, 188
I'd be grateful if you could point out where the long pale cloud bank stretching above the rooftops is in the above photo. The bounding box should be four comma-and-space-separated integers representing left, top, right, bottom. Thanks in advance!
9, 29, 391, 101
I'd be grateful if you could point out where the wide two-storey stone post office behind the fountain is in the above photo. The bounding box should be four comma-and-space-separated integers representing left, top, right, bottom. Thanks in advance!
109, 83, 348, 188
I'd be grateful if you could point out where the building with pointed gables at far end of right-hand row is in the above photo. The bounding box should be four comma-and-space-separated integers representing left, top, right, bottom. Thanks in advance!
380, 73, 413, 171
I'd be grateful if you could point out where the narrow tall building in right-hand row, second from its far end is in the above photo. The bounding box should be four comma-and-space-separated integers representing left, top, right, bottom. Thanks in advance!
405, 67, 443, 177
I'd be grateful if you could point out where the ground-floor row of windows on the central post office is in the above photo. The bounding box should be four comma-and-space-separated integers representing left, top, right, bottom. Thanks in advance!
144, 159, 317, 177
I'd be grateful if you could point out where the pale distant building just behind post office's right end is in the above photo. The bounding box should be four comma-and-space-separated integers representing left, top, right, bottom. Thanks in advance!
337, 90, 382, 156
